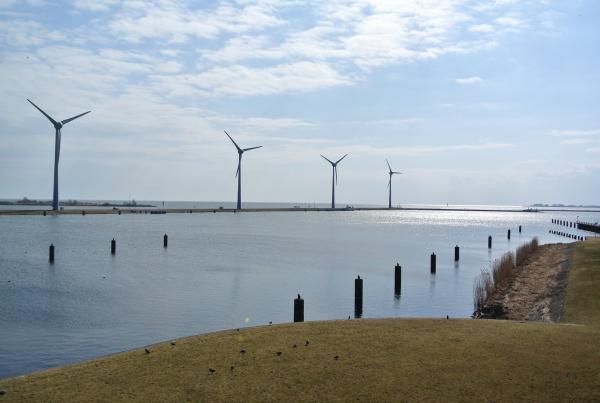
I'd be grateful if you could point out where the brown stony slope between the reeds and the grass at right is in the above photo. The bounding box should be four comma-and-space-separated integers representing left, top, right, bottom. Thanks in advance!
486, 244, 571, 322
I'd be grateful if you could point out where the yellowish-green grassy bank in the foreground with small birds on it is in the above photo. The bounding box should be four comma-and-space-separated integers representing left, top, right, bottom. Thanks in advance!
0, 240, 600, 402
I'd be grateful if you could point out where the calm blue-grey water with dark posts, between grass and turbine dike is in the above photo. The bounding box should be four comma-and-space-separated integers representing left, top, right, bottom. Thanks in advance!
0, 211, 599, 378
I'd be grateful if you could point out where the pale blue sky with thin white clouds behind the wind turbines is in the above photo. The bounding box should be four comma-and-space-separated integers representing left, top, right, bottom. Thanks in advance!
0, 0, 600, 205
